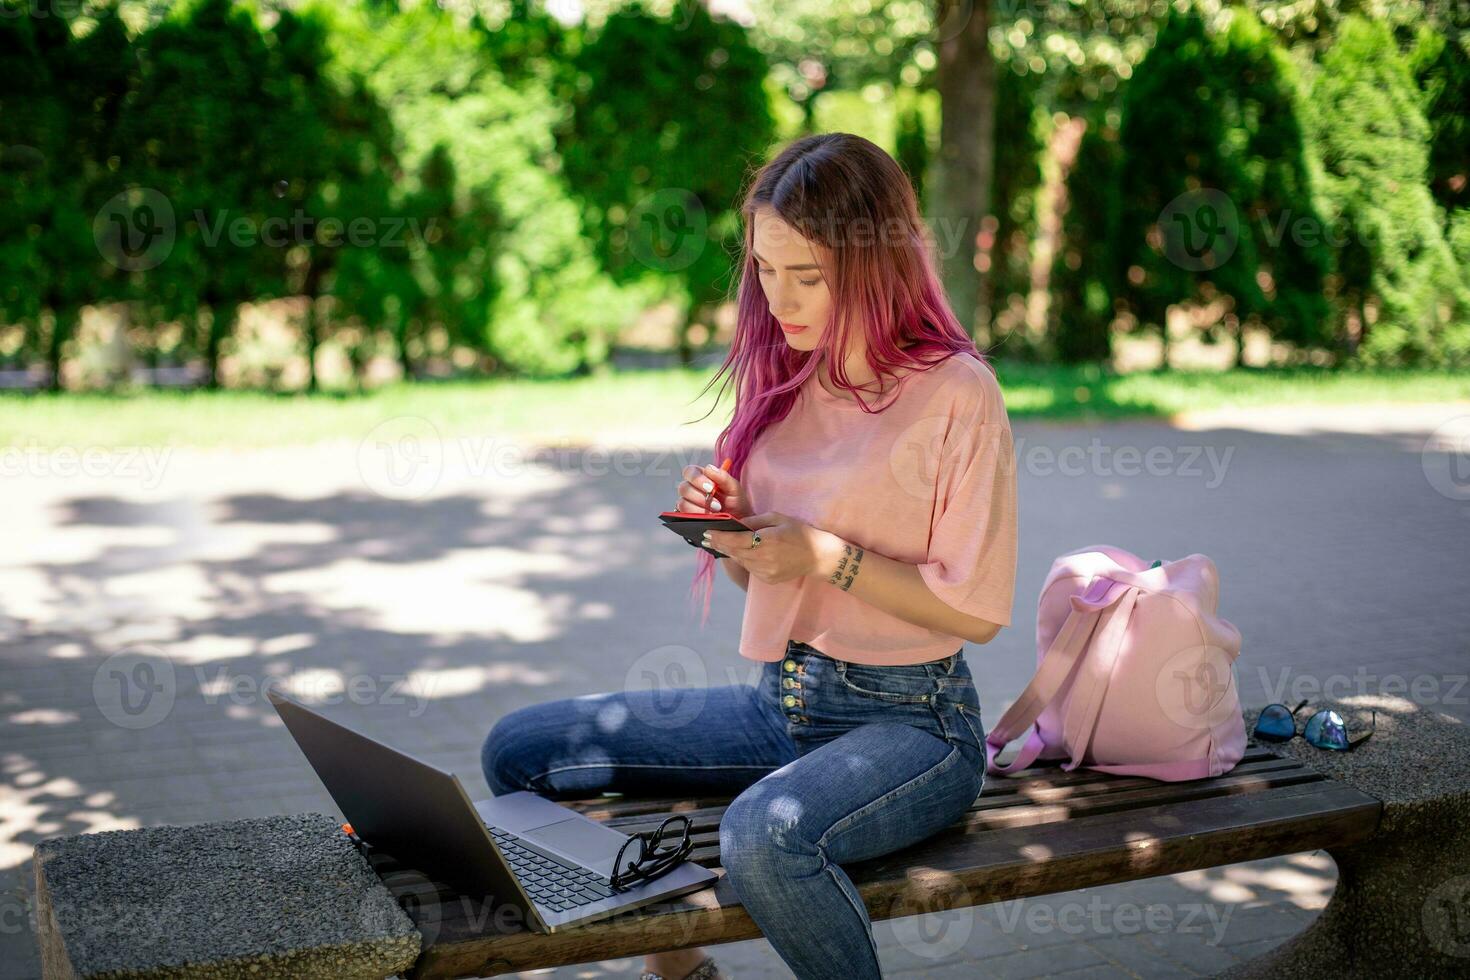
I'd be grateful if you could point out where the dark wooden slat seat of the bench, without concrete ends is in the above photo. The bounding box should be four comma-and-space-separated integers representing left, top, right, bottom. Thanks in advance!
369, 748, 1382, 980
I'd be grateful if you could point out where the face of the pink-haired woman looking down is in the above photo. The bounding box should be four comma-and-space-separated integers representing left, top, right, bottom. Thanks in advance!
753, 207, 832, 351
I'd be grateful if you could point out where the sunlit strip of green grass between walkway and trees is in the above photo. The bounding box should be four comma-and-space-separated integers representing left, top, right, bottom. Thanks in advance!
0, 361, 1470, 448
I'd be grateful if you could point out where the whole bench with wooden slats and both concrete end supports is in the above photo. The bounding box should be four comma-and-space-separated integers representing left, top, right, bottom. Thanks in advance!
35, 696, 1470, 980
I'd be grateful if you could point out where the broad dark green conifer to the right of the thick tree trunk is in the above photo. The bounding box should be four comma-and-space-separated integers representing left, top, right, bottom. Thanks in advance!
1108, 9, 1330, 366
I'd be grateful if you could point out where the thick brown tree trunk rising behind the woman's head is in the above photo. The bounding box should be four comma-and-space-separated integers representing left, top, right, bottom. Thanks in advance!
933, 0, 995, 336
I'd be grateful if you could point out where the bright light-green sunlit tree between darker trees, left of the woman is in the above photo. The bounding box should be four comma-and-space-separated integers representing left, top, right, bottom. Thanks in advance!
320, 3, 629, 375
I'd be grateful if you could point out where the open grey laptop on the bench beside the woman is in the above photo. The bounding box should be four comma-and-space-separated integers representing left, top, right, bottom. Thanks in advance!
266, 688, 719, 933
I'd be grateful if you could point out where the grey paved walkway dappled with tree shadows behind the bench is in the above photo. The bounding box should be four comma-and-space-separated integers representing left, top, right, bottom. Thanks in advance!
0, 404, 1470, 977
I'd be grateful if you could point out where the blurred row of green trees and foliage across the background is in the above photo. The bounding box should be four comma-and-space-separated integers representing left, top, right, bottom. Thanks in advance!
0, 0, 1470, 383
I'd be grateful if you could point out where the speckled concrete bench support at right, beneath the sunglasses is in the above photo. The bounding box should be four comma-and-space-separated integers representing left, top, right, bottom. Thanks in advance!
1222, 695, 1470, 980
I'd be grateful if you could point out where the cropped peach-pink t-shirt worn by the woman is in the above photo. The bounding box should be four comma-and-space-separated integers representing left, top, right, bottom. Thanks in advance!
739, 354, 1017, 666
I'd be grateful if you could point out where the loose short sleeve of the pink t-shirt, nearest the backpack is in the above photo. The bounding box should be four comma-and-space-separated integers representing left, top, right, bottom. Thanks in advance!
919, 416, 1017, 626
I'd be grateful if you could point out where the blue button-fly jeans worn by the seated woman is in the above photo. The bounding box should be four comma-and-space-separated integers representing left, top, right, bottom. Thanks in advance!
481, 641, 985, 980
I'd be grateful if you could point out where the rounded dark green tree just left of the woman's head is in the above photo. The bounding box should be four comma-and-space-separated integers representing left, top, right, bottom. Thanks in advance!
557, 3, 775, 363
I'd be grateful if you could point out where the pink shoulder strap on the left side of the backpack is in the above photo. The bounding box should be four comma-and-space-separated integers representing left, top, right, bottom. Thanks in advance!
985, 576, 1129, 776
